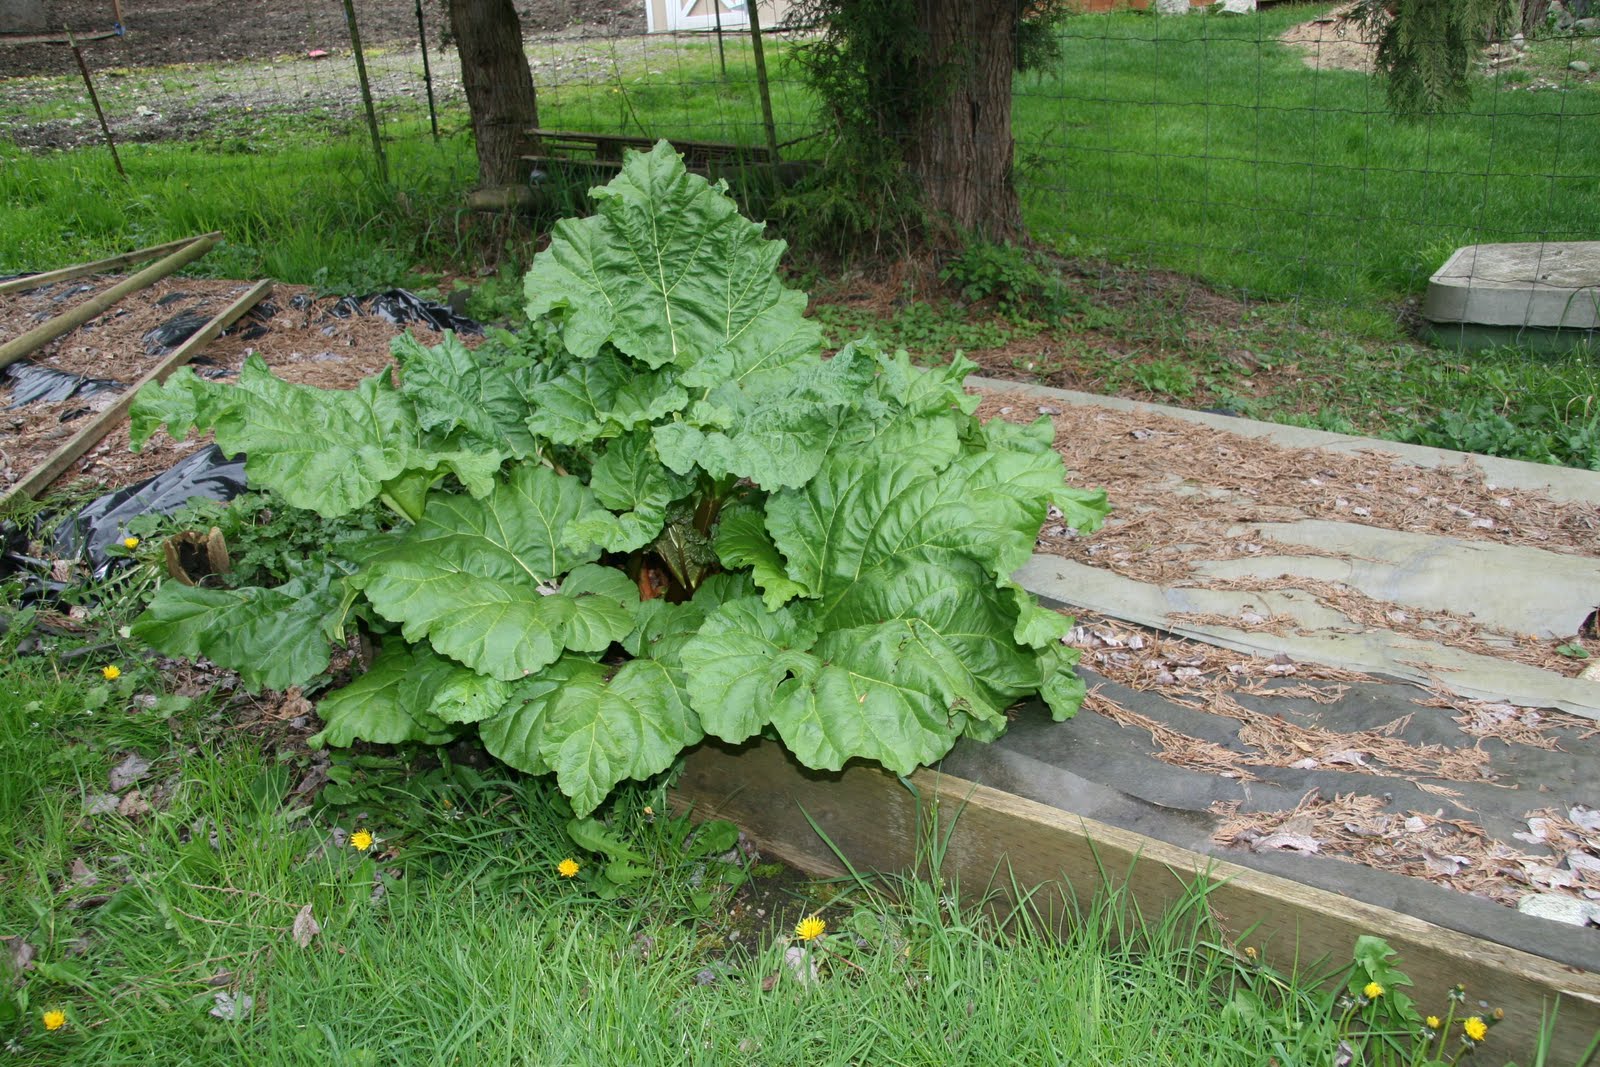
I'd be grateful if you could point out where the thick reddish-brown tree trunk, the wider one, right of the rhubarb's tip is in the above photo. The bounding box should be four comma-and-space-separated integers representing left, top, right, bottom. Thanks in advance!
906, 0, 1022, 240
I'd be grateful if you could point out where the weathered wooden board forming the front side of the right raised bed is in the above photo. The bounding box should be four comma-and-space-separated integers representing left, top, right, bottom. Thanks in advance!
675, 742, 1600, 1064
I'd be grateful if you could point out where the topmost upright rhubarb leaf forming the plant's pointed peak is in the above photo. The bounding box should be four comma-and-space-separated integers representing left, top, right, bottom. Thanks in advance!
526, 141, 819, 377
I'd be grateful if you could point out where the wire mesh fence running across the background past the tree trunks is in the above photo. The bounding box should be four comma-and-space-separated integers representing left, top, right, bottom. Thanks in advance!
0, 0, 1600, 316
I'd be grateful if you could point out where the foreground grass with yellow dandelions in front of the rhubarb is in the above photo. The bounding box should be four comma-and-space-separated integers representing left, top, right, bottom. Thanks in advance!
0, 601, 1459, 1065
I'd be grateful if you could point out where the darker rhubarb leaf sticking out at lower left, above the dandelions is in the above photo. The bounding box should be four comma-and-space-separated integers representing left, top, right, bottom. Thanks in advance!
133, 563, 344, 689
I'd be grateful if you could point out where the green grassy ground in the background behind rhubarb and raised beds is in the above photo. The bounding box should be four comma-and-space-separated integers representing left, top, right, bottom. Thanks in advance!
0, 14, 1600, 467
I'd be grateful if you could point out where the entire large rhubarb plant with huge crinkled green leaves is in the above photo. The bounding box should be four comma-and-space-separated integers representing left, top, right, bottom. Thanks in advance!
124, 142, 1106, 814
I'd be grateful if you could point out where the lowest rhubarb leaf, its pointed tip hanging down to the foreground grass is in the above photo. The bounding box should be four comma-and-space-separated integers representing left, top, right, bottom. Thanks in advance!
480, 657, 704, 816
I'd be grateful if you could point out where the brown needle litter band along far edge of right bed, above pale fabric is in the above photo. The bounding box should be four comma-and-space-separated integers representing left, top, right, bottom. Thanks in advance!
978, 392, 1600, 566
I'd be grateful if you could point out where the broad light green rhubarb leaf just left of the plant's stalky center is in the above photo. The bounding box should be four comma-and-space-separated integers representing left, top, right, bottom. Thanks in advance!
352, 464, 638, 680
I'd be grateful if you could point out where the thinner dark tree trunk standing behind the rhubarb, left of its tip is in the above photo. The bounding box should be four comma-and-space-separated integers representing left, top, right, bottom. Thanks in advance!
450, 0, 539, 186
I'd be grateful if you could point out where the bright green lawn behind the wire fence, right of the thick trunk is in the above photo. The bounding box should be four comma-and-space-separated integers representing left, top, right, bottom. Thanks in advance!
1014, 3, 1600, 306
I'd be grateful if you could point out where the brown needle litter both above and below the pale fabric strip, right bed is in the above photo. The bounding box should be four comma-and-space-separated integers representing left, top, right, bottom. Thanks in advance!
978, 392, 1600, 677
